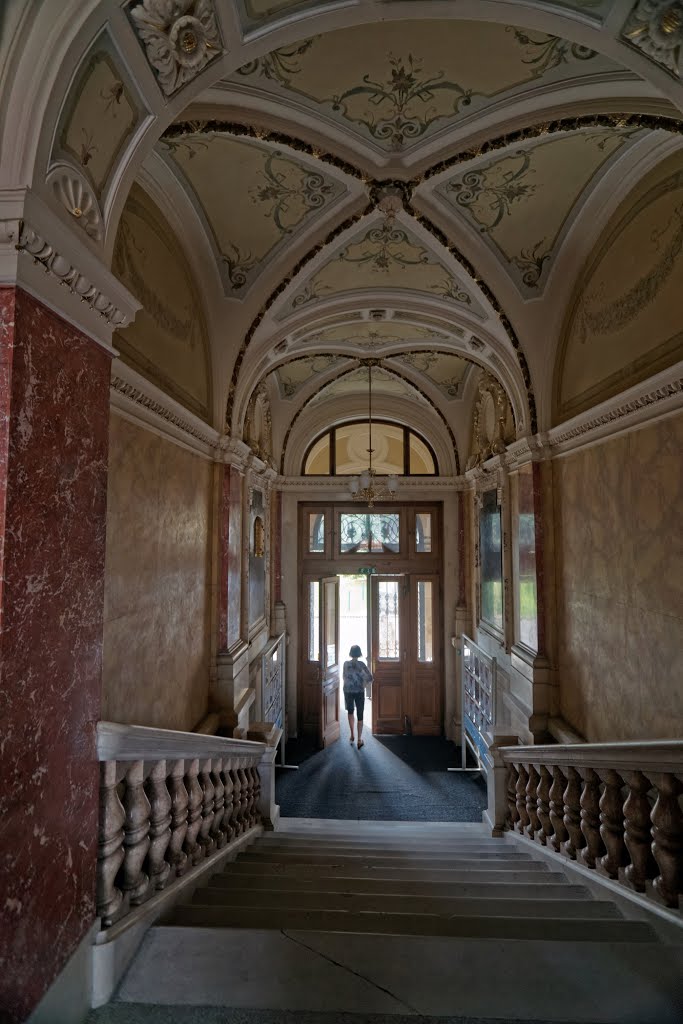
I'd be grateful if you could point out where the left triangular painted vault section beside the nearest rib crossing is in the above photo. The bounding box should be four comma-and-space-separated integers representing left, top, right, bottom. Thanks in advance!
160, 133, 346, 295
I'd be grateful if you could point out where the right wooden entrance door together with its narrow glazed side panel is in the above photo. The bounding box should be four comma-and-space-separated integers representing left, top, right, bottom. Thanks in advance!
372, 573, 441, 735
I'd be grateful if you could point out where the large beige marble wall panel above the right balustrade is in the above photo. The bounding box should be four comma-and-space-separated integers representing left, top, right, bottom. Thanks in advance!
554, 415, 683, 742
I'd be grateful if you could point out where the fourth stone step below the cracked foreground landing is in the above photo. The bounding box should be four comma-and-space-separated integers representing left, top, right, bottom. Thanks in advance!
225, 857, 552, 882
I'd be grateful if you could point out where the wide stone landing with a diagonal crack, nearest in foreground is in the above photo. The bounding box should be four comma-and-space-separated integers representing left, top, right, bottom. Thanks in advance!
113, 923, 683, 1024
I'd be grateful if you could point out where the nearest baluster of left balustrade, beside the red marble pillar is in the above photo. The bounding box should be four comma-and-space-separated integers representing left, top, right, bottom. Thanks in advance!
97, 761, 126, 928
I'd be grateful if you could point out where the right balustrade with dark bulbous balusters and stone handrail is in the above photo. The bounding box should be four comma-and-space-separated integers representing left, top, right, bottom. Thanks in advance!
492, 740, 683, 907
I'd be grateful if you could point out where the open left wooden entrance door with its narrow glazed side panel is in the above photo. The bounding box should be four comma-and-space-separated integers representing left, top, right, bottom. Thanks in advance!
301, 577, 340, 748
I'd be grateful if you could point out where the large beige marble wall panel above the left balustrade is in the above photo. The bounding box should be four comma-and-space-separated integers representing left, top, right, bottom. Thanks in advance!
102, 413, 212, 729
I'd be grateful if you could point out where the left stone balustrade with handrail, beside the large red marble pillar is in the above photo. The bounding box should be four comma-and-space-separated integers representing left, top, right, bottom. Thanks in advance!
97, 722, 275, 928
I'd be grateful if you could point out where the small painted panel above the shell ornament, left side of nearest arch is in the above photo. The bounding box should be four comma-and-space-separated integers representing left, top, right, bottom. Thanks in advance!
52, 35, 141, 198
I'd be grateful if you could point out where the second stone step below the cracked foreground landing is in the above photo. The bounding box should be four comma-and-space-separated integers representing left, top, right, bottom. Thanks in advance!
186, 887, 622, 920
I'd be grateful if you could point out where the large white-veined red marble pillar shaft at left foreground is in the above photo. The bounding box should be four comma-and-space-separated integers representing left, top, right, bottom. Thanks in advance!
0, 289, 110, 1022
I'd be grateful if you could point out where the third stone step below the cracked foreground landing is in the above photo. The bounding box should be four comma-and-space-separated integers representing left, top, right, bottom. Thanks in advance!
210, 871, 591, 900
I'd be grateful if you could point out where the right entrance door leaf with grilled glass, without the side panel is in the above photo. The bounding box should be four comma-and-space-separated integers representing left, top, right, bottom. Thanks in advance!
371, 575, 408, 733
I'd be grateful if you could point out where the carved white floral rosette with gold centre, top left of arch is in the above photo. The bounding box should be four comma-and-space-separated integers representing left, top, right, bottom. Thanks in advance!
130, 0, 222, 96
